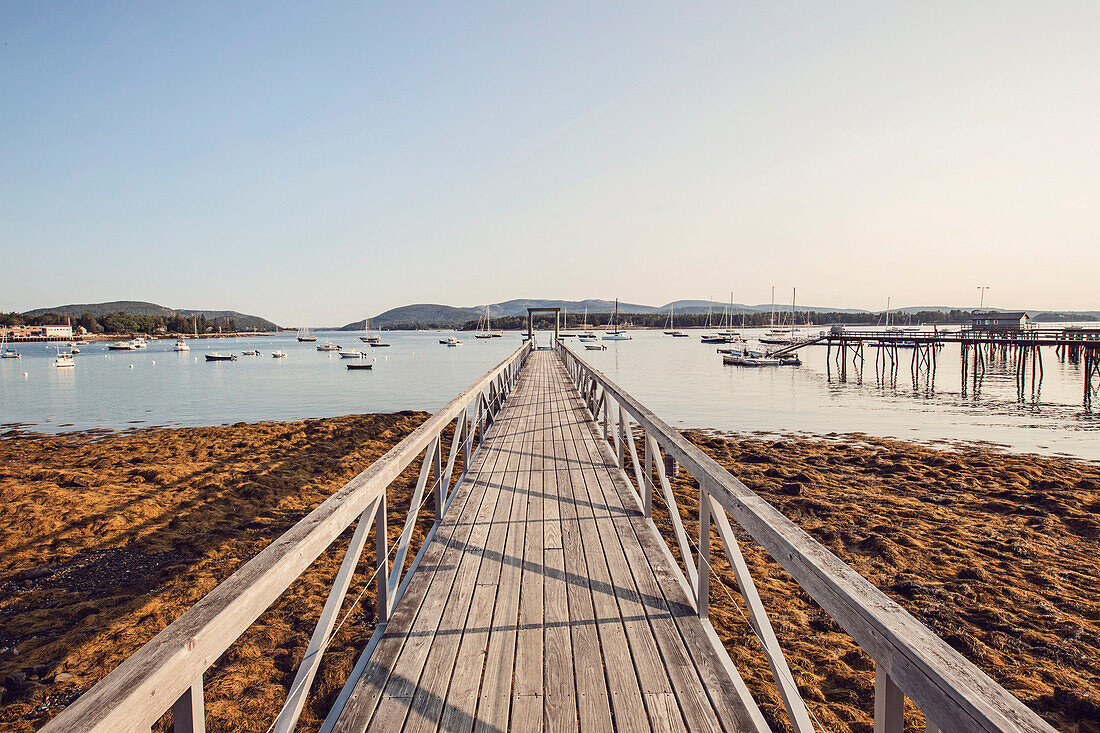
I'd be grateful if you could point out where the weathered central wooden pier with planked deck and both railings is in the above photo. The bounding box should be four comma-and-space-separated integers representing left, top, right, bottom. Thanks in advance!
44, 342, 1053, 733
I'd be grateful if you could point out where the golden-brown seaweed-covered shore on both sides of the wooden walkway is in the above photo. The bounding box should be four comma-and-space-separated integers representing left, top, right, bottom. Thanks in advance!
0, 420, 1100, 733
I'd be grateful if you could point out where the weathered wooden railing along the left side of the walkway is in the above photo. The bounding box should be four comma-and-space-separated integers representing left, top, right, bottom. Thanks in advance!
42, 343, 530, 733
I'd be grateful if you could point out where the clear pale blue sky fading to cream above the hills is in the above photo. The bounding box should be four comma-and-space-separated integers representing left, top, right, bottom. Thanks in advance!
0, 0, 1100, 325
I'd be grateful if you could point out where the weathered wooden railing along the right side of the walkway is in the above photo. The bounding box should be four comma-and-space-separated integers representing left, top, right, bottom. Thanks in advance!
558, 343, 1054, 733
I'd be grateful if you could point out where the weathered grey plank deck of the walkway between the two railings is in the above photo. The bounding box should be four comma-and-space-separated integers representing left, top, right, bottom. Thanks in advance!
334, 351, 760, 731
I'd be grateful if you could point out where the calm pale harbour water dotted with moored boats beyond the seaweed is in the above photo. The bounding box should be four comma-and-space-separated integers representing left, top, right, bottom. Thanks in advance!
0, 331, 1100, 460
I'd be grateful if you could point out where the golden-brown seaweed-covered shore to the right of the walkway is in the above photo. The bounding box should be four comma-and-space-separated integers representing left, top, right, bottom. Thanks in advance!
668, 430, 1100, 733
